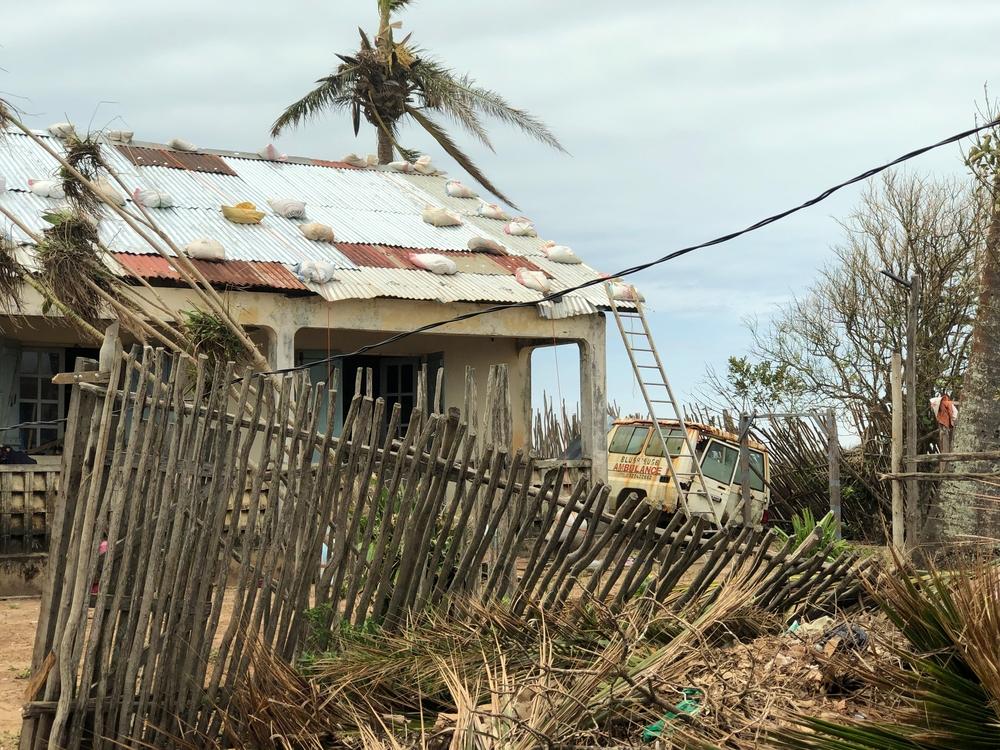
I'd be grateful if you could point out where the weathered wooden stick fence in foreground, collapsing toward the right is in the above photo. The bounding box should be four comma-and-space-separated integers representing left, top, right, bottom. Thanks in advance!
21, 348, 863, 750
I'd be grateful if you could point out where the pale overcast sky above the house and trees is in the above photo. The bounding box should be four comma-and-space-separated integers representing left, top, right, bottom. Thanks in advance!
0, 0, 1000, 409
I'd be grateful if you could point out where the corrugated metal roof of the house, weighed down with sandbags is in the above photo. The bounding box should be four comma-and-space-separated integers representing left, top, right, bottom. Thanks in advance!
0, 128, 632, 317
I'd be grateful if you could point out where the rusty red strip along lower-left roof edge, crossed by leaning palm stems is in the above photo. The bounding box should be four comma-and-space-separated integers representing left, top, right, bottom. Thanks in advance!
115, 253, 309, 292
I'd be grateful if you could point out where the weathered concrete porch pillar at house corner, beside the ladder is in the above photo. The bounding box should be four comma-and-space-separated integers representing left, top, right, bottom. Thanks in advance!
578, 314, 608, 482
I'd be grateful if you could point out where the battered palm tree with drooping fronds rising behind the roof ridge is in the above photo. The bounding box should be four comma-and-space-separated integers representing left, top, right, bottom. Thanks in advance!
271, 0, 564, 206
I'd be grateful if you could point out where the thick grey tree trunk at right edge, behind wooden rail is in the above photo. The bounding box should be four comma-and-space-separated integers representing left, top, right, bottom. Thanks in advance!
928, 175, 1000, 543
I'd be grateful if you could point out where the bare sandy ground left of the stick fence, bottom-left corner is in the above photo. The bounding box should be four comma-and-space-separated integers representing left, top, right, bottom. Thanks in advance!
0, 598, 40, 750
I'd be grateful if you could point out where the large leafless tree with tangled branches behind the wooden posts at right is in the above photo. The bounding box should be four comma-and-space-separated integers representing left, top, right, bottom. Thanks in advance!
708, 173, 988, 451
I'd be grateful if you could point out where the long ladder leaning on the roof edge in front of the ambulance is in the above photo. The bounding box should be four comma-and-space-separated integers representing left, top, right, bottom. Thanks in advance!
605, 283, 722, 527
